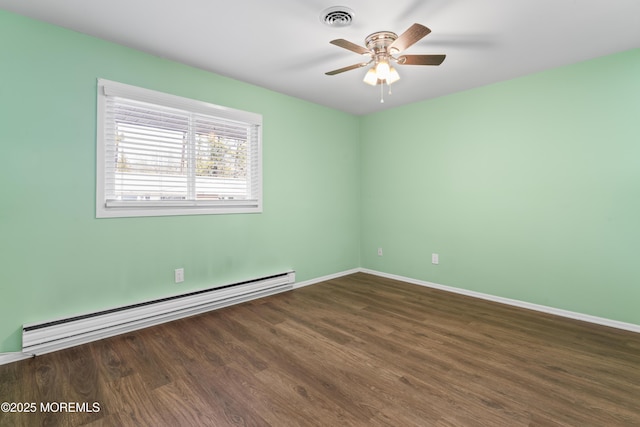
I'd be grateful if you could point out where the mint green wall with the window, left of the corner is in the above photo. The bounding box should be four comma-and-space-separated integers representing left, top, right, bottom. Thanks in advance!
0, 11, 360, 352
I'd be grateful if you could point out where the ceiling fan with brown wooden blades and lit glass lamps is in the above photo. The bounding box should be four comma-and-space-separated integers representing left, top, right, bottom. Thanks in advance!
325, 24, 446, 86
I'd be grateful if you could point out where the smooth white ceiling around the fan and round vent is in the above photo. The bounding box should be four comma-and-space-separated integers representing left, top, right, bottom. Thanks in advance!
0, 0, 640, 115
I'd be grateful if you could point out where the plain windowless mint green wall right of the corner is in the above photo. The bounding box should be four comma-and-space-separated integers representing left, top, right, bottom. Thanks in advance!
361, 49, 640, 324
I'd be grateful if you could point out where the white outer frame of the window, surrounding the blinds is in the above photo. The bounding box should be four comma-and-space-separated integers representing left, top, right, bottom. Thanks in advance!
96, 79, 262, 218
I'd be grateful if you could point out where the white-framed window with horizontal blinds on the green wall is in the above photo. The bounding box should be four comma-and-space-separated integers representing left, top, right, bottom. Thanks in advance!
96, 79, 262, 218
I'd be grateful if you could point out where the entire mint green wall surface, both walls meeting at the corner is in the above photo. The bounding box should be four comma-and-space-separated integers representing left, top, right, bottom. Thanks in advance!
0, 11, 640, 352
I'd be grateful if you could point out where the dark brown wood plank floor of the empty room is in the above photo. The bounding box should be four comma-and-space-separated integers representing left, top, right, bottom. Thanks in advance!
0, 274, 640, 427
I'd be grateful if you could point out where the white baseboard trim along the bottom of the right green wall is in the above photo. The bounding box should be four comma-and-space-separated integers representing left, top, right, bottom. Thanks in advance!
359, 268, 640, 333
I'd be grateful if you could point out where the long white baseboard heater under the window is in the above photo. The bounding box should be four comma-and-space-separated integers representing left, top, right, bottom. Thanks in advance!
22, 271, 295, 355
